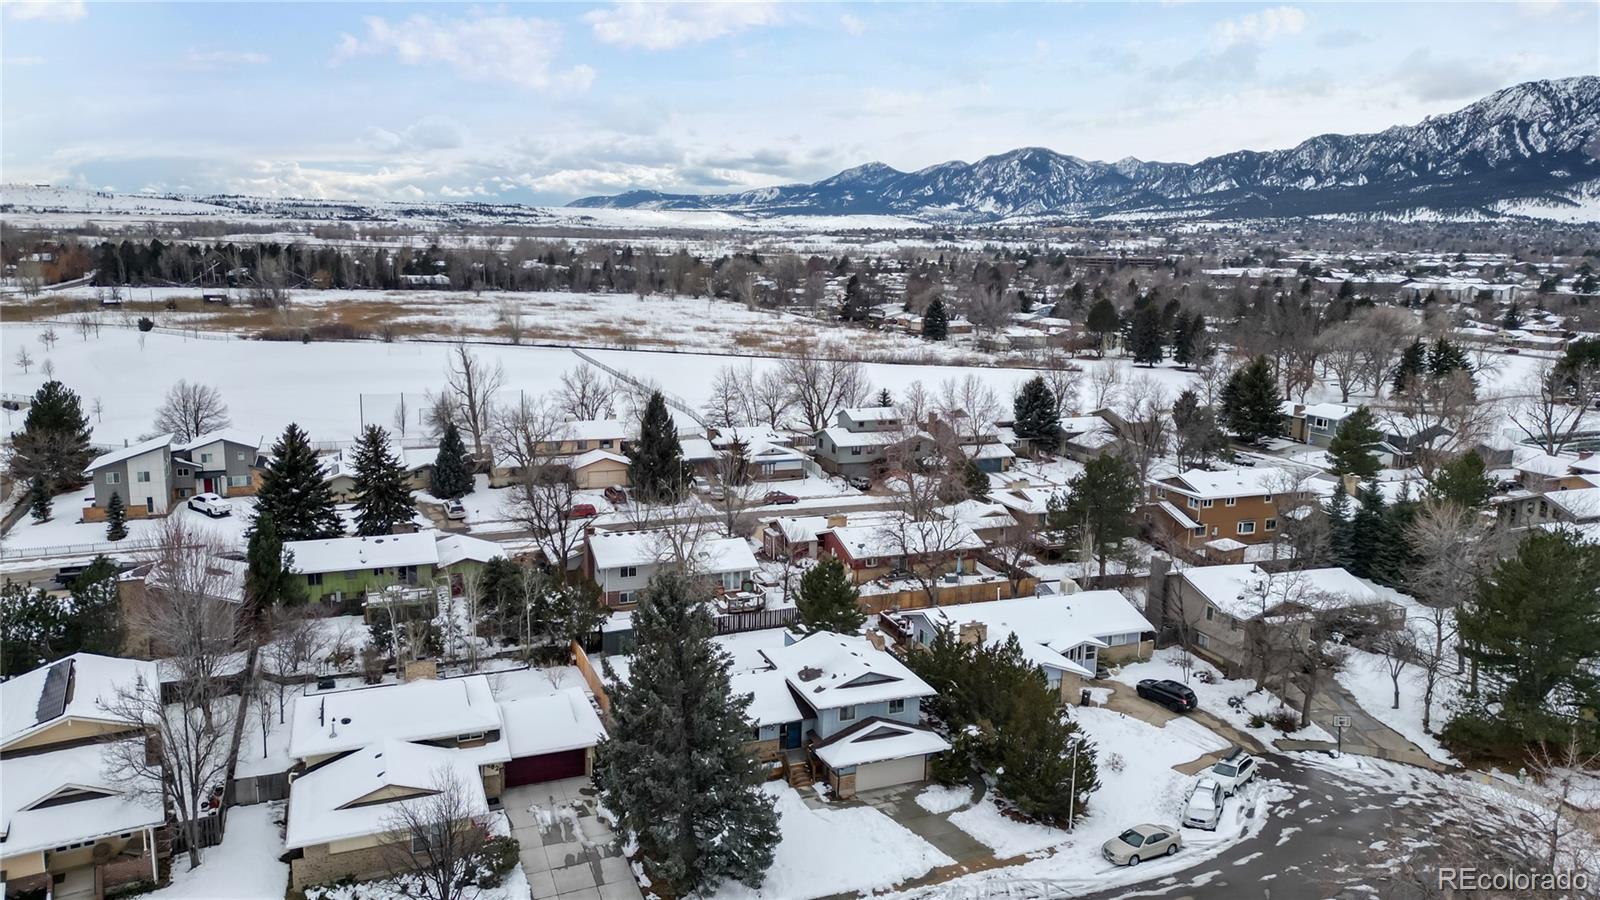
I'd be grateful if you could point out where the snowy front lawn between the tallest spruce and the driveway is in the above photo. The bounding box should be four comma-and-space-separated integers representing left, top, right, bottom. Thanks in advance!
714, 781, 954, 900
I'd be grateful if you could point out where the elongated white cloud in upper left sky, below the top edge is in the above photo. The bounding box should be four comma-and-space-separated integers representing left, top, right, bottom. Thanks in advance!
333, 14, 595, 90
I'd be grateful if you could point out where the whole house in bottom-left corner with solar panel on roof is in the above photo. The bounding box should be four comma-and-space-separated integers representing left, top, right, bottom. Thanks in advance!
0, 653, 170, 900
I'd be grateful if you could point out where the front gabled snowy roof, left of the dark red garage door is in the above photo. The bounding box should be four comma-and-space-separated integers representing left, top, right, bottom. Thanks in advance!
283, 740, 490, 850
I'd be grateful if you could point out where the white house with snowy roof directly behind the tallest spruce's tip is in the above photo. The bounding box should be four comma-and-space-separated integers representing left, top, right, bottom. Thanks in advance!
584, 530, 758, 609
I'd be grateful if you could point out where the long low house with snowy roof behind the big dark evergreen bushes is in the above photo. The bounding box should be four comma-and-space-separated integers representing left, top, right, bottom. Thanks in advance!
894, 591, 1155, 701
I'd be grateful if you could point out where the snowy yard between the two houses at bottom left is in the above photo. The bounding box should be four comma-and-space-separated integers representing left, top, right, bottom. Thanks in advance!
146, 802, 290, 900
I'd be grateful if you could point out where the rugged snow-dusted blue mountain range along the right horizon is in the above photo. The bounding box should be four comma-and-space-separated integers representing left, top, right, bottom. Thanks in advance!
571, 75, 1600, 221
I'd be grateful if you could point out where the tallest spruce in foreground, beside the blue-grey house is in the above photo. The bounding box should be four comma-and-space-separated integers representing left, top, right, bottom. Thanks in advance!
595, 572, 777, 897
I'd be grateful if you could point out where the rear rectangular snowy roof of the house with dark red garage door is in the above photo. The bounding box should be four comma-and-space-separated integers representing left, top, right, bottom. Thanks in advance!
290, 674, 509, 762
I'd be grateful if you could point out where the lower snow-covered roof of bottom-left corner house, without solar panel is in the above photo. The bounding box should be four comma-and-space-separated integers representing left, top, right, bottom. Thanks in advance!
0, 736, 166, 857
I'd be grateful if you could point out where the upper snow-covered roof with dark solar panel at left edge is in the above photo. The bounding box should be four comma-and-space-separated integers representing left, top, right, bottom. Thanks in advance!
0, 653, 160, 746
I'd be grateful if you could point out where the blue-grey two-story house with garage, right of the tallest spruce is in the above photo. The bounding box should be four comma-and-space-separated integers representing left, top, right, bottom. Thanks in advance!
760, 631, 950, 798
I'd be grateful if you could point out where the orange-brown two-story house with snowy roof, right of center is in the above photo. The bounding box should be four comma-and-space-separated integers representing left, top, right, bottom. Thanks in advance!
1144, 466, 1309, 549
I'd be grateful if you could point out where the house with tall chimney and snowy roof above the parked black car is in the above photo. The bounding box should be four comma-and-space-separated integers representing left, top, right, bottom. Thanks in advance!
1163, 564, 1403, 674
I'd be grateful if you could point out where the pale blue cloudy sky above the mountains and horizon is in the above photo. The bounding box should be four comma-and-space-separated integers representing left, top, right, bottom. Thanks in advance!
0, 2, 1600, 203
